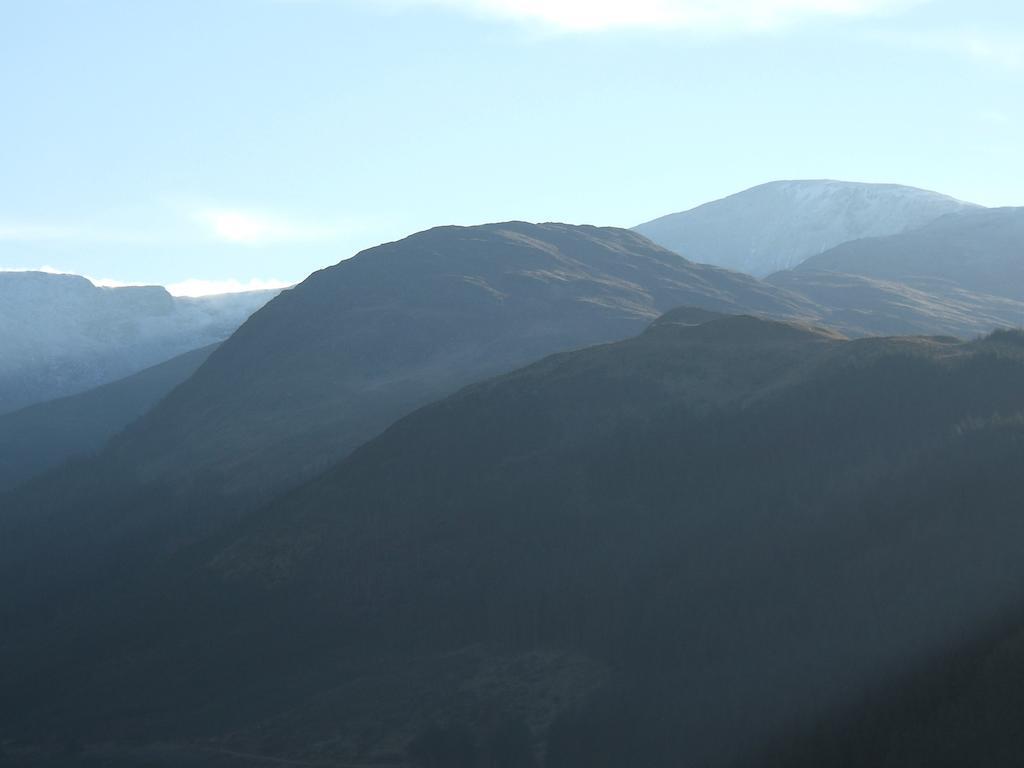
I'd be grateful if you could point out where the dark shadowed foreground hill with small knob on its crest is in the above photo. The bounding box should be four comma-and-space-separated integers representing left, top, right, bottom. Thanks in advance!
0, 311, 1024, 768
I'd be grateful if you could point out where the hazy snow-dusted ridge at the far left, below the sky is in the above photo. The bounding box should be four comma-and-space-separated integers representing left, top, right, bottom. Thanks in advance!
0, 272, 278, 414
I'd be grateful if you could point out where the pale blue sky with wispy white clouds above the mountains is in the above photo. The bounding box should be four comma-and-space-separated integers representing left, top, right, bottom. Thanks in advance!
0, 0, 1024, 295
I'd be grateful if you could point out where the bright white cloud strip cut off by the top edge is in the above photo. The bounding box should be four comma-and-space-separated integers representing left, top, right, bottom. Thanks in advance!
380, 0, 929, 32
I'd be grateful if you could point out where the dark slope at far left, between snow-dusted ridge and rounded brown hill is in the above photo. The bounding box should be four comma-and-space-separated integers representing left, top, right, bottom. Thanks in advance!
0, 345, 216, 492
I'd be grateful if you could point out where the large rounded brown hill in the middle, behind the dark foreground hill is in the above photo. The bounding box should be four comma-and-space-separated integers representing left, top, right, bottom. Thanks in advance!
0, 227, 819, 638
